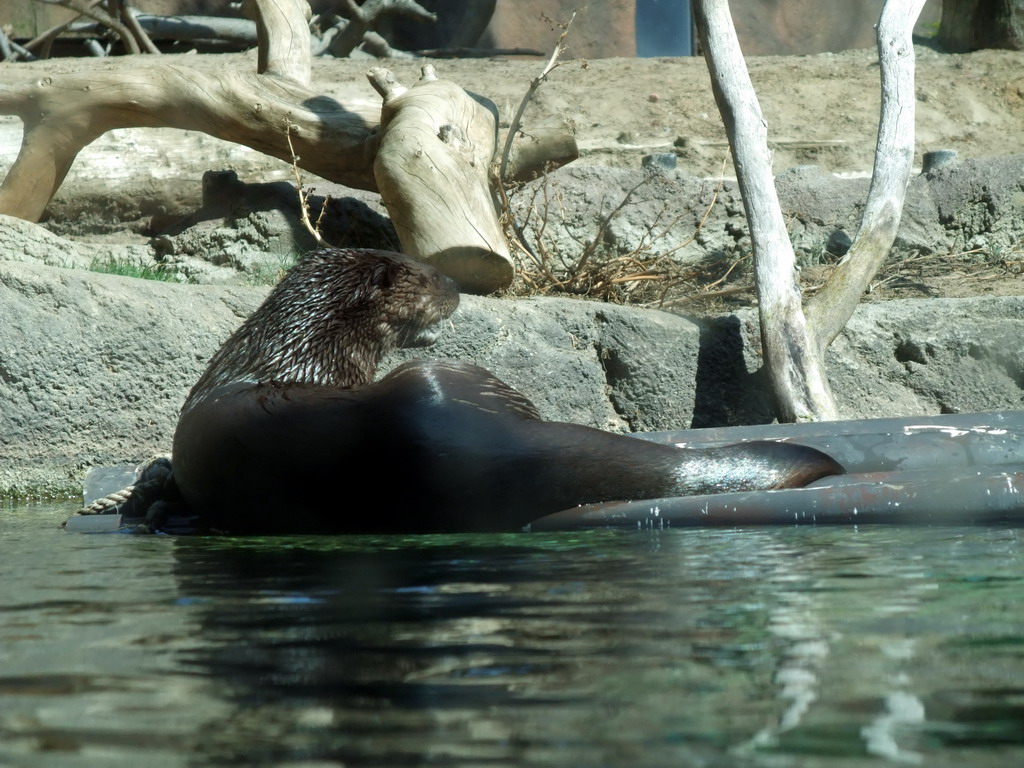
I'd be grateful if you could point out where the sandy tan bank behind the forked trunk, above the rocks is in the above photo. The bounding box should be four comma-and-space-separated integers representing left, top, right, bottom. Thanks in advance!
364, 46, 1024, 176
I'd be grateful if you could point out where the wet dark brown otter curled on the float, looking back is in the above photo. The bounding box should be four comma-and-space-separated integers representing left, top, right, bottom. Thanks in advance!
173, 249, 842, 534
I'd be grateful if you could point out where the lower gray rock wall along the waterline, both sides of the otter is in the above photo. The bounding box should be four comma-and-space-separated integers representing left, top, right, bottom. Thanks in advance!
0, 261, 1024, 497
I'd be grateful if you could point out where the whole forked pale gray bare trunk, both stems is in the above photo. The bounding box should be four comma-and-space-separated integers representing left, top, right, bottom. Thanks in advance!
694, 0, 925, 421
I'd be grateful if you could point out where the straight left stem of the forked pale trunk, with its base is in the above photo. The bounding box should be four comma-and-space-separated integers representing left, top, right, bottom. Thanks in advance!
694, 0, 839, 422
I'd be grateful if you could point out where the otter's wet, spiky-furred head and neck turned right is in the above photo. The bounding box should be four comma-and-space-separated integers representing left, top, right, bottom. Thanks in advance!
185, 248, 459, 409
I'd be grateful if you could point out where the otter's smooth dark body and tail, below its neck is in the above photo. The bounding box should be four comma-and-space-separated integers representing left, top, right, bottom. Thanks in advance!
174, 362, 842, 534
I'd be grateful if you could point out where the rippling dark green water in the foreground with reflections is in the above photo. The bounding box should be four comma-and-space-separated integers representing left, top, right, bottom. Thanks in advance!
0, 505, 1024, 768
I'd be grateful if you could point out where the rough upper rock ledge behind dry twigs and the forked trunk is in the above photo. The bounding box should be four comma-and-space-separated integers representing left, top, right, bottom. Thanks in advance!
512, 155, 1024, 274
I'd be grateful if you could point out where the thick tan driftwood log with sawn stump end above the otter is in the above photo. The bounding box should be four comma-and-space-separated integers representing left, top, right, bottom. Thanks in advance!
0, 0, 574, 293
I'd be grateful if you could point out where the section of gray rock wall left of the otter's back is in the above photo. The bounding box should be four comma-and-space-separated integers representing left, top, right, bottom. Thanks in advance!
0, 262, 265, 496
